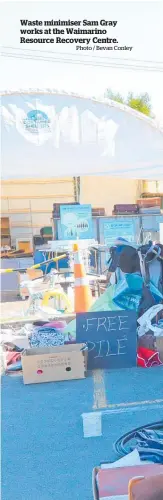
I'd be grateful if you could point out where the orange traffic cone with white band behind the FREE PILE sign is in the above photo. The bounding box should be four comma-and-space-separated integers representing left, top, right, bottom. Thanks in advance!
73, 243, 92, 313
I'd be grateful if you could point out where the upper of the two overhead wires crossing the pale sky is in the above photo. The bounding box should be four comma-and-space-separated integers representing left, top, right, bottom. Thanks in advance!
2, 45, 163, 64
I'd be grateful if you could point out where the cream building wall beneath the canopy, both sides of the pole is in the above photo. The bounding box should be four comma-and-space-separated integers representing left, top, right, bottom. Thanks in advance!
1, 176, 141, 245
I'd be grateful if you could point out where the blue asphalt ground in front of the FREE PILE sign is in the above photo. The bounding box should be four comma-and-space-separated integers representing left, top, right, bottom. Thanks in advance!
2, 367, 163, 500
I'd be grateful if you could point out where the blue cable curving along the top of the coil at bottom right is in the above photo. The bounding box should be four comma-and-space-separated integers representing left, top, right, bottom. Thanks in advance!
113, 420, 163, 457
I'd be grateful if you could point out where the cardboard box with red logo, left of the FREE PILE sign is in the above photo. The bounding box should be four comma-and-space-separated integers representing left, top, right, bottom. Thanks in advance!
22, 344, 88, 384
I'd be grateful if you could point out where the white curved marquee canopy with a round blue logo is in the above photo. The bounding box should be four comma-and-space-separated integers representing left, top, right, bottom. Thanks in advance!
1, 90, 163, 180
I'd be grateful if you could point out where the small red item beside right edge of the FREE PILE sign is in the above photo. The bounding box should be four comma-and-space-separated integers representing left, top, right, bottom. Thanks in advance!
137, 347, 163, 368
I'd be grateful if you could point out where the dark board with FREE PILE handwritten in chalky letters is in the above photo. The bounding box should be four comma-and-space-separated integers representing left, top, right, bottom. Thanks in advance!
76, 311, 137, 370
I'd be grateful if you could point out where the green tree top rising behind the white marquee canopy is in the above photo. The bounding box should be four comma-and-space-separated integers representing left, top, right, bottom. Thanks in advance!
105, 89, 151, 116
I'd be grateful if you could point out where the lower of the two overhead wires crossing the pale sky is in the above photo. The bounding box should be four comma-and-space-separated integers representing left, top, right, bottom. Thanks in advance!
1, 52, 163, 73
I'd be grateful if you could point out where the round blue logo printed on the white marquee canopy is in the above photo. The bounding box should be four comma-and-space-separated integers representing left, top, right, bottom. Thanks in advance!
23, 110, 50, 134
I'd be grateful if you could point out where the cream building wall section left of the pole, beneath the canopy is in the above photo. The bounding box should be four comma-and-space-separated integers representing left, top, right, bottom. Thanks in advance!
1, 177, 75, 246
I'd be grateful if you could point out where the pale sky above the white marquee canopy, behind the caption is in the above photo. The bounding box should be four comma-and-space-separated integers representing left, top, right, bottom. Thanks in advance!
0, 0, 163, 125
